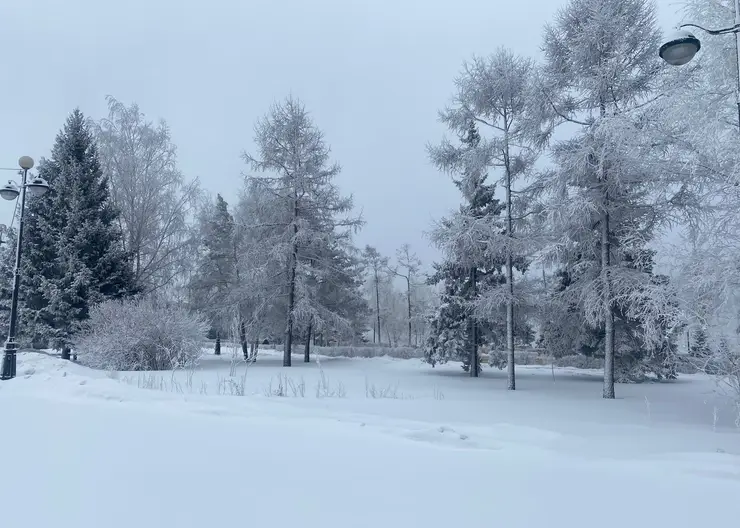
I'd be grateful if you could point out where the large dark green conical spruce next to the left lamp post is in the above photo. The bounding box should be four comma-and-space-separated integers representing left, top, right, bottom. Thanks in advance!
23, 110, 134, 359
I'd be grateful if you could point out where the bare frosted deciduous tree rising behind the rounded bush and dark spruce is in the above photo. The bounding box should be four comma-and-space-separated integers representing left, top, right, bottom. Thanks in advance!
95, 97, 200, 293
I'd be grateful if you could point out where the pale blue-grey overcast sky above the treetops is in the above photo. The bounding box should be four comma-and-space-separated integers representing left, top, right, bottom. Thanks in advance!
0, 0, 680, 267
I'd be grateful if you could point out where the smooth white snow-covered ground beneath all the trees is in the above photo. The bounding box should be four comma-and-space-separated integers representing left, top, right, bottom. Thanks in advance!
0, 352, 740, 528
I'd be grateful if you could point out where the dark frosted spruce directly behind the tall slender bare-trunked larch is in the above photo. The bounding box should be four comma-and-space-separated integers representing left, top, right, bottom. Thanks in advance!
425, 121, 524, 376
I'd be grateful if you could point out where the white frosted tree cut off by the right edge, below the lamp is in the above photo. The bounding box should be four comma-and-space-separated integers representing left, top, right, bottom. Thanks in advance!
666, 0, 740, 402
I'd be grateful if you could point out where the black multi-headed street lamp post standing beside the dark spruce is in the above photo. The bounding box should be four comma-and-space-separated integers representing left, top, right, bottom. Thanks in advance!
0, 156, 49, 380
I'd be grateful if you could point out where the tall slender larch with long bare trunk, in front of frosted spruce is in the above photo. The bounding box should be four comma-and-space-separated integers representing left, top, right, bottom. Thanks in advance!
431, 48, 539, 390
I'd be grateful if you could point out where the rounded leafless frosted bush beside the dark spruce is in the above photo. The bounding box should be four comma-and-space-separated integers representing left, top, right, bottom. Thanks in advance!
76, 299, 208, 370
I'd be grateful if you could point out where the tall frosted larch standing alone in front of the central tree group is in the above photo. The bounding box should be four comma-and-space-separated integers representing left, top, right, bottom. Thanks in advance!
244, 97, 361, 366
